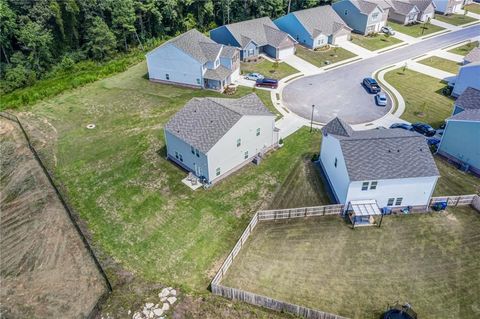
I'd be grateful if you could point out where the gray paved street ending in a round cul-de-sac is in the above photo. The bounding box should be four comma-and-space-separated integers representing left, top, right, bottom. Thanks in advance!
282, 25, 480, 124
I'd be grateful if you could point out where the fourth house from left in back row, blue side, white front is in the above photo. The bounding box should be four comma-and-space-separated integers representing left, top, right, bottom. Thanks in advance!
332, 0, 388, 35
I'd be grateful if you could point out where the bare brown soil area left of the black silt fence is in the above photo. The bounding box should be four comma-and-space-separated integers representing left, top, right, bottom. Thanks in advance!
0, 119, 106, 318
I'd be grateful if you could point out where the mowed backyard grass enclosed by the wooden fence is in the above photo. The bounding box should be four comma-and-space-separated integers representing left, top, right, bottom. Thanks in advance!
222, 207, 480, 319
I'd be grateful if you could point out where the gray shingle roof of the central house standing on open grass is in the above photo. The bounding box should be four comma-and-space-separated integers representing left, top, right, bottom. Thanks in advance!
165, 93, 274, 154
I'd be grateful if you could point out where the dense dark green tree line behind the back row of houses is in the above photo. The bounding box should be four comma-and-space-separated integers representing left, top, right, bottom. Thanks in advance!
0, 0, 330, 93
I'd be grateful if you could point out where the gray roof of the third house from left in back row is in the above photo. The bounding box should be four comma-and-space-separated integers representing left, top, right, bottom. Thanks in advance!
290, 5, 351, 37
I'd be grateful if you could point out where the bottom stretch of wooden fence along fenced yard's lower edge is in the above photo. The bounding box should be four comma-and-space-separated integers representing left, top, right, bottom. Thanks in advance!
212, 283, 345, 319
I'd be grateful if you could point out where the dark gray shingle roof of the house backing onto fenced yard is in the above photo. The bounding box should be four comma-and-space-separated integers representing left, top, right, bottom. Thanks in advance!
324, 118, 439, 181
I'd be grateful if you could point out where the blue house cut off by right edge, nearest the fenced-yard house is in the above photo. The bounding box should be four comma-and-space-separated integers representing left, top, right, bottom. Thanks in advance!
437, 87, 480, 175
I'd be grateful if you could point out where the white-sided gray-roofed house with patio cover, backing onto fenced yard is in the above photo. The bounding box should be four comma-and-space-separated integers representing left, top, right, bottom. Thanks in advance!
319, 118, 439, 209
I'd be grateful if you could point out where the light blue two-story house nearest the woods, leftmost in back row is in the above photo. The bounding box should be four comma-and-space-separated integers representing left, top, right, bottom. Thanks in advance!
146, 29, 240, 91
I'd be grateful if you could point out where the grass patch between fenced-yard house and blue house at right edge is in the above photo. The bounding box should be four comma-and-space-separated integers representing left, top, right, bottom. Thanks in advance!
433, 156, 480, 196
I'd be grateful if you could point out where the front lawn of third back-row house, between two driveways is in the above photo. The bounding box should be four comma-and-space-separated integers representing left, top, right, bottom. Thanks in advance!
295, 45, 356, 68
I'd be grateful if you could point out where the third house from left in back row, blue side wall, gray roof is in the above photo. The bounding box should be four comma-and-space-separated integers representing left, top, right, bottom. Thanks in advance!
274, 5, 352, 49
